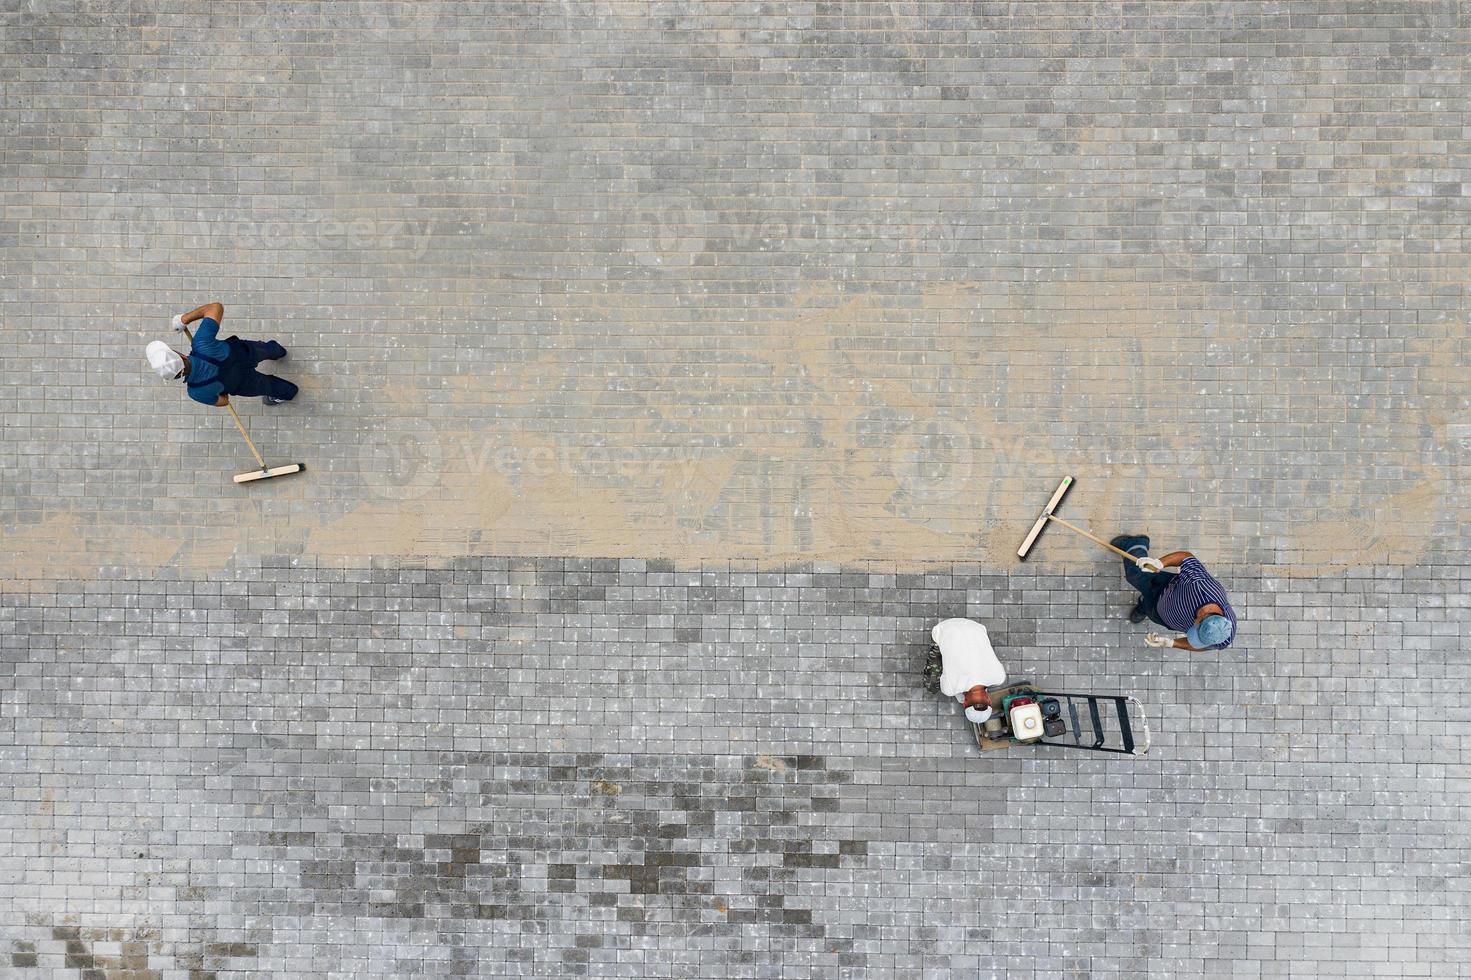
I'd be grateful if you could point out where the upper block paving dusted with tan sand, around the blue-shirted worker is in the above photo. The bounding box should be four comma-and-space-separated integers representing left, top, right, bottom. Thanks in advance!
0, 0, 1471, 580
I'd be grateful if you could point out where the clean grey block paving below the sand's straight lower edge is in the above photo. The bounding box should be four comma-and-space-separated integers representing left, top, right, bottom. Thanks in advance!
0, 559, 1471, 979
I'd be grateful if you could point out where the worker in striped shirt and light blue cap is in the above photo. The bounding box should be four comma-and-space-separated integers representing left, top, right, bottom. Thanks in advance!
1114, 534, 1236, 652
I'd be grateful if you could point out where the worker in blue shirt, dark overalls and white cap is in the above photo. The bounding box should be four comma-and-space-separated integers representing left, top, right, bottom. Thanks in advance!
147, 303, 299, 408
